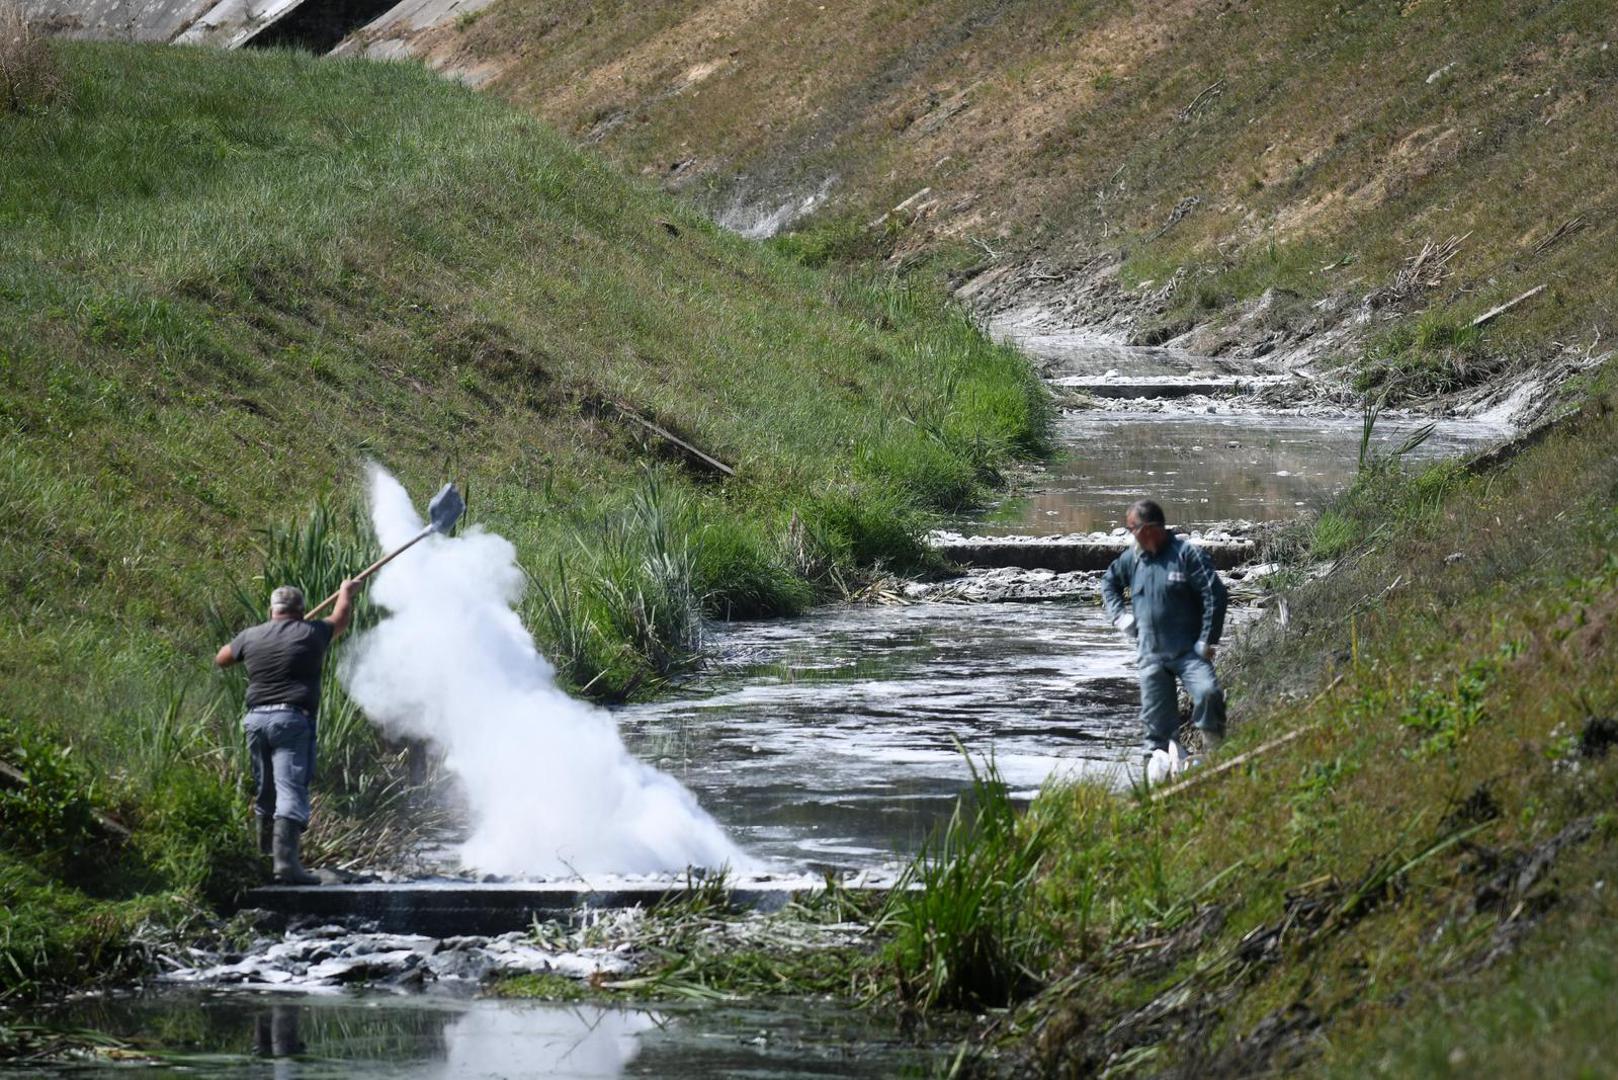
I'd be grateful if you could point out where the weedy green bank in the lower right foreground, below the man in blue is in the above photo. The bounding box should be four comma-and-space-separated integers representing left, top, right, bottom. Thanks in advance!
892, 366, 1618, 1077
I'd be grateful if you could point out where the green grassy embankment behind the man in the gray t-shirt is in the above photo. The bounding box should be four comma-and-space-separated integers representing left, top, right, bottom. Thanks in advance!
0, 44, 1045, 996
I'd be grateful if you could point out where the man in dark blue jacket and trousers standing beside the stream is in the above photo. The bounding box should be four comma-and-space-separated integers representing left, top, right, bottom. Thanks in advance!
1102, 499, 1226, 756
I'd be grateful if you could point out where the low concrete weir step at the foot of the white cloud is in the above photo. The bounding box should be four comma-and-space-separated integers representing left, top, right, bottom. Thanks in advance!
243, 878, 887, 938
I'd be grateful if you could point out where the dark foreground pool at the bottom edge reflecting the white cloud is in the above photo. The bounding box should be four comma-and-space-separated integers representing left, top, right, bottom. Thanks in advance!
29, 991, 927, 1080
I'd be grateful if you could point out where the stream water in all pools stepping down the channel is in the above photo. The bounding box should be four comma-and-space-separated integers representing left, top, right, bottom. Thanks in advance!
22, 335, 1503, 1078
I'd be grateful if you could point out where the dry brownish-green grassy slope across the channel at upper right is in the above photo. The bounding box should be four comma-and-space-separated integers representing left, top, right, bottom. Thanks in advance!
436, 0, 1618, 392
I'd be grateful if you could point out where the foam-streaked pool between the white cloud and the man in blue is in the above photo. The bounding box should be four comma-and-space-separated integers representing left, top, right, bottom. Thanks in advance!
620, 602, 1136, 868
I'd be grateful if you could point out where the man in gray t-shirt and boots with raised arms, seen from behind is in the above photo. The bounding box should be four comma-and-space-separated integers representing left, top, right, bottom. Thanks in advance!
214, 580, 358, 886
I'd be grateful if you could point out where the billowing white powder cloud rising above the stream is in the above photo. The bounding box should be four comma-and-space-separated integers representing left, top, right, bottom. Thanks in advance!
340, 466, 752, 878
